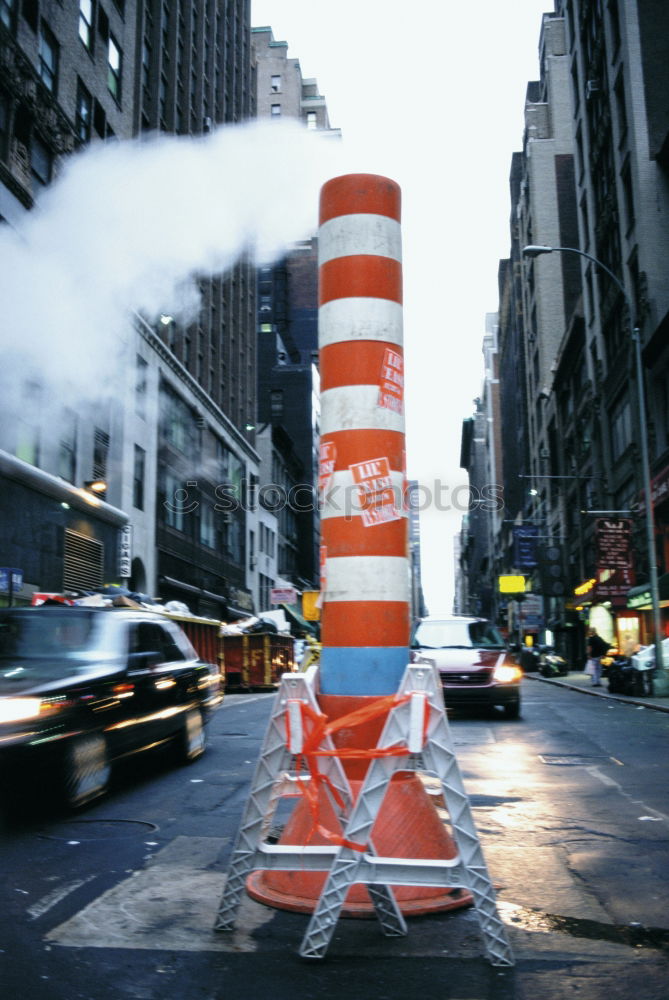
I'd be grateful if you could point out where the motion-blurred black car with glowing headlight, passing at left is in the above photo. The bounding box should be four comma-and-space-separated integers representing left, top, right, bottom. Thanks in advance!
0, 605, 222, 806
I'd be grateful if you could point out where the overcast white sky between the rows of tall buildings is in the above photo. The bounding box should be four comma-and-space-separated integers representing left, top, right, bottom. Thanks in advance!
251, 0, 554, 612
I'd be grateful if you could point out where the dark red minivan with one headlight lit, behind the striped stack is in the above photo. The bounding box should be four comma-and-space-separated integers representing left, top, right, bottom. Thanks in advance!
411, 616, 523, 719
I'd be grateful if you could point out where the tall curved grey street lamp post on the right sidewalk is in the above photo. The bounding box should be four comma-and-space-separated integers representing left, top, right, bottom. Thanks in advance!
523, 245, 669, 694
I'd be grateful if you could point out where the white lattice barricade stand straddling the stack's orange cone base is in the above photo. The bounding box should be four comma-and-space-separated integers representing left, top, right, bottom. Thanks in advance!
214, 663, 514, 966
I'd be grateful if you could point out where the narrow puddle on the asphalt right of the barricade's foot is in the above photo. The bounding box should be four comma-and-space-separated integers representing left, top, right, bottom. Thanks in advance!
497, 900, 669, 952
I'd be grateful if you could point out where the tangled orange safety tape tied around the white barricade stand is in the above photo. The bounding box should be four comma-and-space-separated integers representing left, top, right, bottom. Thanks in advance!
286, 694, 422, 853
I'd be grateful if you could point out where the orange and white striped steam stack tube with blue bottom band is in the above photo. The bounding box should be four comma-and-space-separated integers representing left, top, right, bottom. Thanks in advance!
318, 174, 409, 696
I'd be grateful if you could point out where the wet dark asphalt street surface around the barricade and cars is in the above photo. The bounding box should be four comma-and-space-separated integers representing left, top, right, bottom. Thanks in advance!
0, 677, 669, 1000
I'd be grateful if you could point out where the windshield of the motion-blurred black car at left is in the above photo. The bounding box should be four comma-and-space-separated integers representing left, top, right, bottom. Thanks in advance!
0, 608, 105, 681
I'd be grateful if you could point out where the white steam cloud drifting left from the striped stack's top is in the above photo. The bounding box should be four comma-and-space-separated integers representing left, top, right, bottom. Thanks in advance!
0, 122, 343, 397
